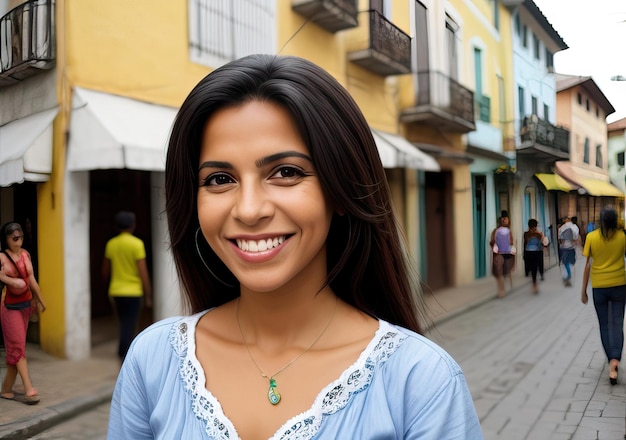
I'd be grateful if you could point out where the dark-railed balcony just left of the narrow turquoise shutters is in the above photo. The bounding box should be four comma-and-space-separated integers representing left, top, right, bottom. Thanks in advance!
400, 71, 476, 133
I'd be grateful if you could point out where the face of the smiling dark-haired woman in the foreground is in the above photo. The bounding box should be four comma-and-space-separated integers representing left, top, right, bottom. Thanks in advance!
197, 101, 333, 292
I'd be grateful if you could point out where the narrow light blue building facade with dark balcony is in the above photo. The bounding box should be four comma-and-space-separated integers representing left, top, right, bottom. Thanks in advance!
512, 0, 569, 267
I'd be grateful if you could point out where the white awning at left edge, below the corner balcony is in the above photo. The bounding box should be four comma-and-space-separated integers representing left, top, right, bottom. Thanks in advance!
0, 107, 59, 186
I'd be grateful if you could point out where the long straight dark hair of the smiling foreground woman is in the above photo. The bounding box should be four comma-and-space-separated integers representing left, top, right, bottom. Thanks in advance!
165, 55, 421, 332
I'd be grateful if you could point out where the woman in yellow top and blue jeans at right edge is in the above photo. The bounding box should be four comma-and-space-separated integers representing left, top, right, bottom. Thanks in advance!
581, 207, 626, 385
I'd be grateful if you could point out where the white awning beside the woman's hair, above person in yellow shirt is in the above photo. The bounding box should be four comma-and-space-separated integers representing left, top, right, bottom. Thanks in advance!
67, 87, 178, 171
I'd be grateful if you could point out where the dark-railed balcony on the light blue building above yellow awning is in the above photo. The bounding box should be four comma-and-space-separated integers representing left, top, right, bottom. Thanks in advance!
517, 115, 570, 160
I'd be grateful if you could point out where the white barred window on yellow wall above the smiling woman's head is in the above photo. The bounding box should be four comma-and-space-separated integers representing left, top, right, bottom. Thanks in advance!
188, 0, 276, 67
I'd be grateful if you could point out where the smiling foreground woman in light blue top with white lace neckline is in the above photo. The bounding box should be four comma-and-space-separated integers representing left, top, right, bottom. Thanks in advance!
109, 55, 482, 439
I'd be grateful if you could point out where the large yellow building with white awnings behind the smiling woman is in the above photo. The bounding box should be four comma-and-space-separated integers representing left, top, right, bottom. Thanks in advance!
0, 0, 442, 359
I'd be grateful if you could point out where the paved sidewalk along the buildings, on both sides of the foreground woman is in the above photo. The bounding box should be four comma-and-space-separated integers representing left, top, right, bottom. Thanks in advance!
0, 266, 530, 439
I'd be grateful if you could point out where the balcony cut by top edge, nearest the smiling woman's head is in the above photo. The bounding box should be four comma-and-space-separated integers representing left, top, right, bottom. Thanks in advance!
291, 0, 359, 33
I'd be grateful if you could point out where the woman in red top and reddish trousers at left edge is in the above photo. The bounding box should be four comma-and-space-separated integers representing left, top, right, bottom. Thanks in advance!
0, 222, 46, 405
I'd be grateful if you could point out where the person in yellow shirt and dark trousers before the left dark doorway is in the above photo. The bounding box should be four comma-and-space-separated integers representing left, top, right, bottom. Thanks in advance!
102, 211, 152, 361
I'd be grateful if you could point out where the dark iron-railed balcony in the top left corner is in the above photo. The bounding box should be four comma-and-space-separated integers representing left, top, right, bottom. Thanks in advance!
0, 0, 56, 87
